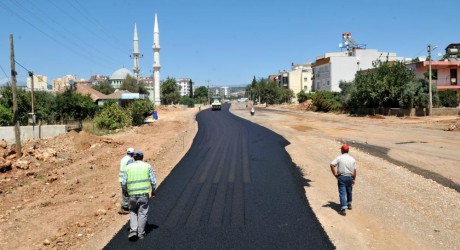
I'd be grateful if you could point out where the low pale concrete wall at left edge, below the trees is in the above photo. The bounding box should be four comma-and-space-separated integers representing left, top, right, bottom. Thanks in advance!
0, 125, 67, 144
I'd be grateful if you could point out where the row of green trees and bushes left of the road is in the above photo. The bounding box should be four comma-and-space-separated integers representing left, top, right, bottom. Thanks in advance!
0, 79, 155, 130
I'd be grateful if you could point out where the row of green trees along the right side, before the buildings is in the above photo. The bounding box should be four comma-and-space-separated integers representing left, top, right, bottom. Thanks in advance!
246, 61, 459, 112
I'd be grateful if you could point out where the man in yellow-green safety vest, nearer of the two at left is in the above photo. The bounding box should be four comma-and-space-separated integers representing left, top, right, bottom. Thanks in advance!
122, 150, 157, 239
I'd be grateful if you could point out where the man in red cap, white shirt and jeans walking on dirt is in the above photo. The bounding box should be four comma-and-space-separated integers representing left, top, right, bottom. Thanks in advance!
331, 144, 356, 215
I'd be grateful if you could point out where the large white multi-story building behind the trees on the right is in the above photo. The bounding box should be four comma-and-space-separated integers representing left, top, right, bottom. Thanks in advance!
312, 48, 403, 92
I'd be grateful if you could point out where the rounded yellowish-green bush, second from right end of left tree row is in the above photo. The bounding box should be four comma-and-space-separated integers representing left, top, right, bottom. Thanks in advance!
96, 103, 132, 130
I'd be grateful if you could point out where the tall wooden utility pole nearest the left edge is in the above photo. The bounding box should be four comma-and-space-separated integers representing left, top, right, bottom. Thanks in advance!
10, 34, 22, 159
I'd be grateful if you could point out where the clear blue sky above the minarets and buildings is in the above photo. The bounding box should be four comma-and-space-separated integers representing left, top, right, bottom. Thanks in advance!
0, 0, 460, 86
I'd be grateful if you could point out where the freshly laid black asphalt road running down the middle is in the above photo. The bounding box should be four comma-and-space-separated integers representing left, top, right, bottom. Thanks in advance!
105, 104, 334, 249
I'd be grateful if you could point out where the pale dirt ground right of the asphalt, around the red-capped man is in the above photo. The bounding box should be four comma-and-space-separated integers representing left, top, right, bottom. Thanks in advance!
232, 102, 460, 249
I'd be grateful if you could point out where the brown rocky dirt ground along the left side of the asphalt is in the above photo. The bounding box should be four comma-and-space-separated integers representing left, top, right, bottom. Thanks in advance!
0, 107, 198, 249
